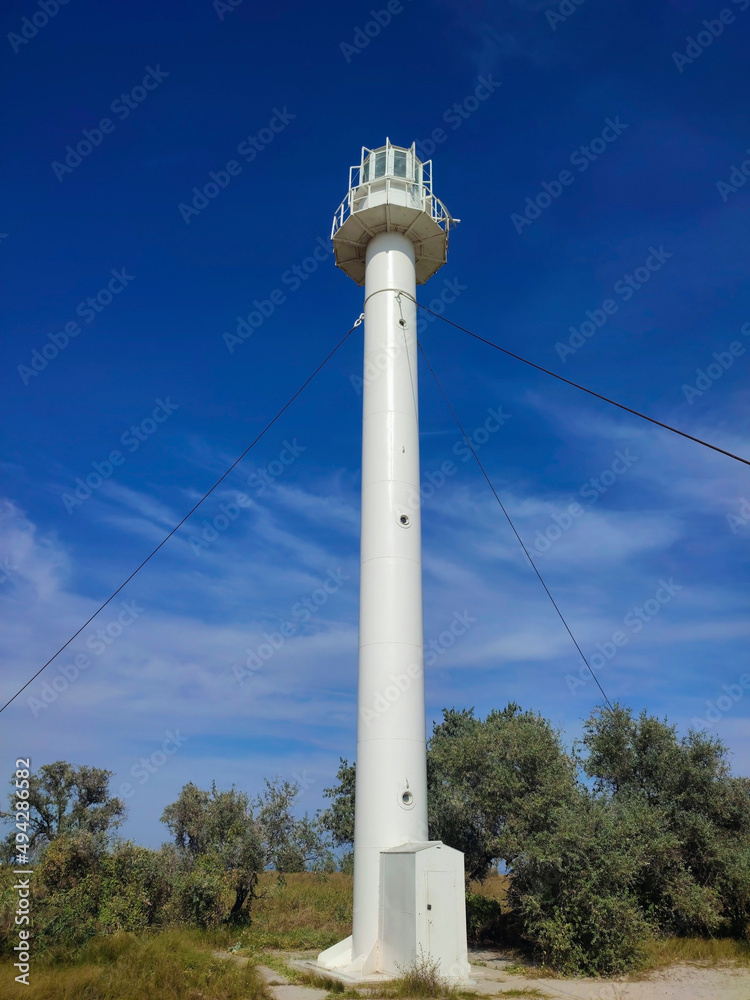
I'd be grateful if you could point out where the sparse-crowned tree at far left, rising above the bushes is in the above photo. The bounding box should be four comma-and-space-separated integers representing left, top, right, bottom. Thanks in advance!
0, 760, 125, 854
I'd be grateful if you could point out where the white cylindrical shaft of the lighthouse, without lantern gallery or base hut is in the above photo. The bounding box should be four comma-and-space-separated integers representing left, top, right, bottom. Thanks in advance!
352, 232, 427, 956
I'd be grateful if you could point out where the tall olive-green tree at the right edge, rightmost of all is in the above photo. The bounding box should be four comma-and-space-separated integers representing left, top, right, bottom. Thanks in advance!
579, 705, 750, 935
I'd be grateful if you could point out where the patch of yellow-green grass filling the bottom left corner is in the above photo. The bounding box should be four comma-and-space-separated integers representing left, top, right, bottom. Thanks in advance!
2, 930, 268, 1000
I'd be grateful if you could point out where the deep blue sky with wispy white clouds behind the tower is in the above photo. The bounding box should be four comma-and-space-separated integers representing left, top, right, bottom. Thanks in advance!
0, 0, 750, 844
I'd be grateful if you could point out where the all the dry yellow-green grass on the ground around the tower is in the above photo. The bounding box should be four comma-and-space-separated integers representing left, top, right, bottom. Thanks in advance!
0, 873, 750, 1000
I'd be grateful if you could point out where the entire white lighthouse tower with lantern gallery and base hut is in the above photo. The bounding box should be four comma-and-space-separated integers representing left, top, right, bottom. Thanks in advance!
318, 140, 469, 982
